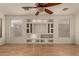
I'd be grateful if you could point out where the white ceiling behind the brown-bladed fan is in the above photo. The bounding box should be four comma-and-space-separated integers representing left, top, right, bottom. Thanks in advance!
0, 3, 79, 15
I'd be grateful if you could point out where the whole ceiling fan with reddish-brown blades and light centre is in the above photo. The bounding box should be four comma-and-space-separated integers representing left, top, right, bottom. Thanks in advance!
22, 3, 62, 16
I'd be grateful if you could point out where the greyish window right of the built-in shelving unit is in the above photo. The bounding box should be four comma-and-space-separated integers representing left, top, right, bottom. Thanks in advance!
58, 24, 70, 37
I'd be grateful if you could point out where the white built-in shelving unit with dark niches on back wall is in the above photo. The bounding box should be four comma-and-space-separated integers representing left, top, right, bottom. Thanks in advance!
26, 19, 54, 44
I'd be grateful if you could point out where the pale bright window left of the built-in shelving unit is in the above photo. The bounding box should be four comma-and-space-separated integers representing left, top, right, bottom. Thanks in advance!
11, 20, 22, 37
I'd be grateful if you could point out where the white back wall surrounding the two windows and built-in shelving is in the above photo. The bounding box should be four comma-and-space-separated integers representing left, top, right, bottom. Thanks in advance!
5, 15, 75, 44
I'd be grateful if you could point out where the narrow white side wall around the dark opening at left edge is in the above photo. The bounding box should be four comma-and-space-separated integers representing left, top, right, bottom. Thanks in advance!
0, 13, 5, 45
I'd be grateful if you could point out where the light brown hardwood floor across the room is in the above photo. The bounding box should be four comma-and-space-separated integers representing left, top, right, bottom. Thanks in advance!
0, 44, 79, 56
